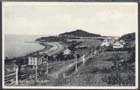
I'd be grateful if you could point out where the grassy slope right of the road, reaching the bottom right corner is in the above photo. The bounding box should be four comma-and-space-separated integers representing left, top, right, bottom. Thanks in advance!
52, 51, 135, 86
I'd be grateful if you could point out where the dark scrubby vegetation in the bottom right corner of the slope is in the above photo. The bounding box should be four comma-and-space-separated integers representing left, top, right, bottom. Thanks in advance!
102, 50, 135, 86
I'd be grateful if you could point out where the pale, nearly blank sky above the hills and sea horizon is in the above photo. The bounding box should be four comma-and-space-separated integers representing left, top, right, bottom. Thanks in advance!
3, 2, 138, 36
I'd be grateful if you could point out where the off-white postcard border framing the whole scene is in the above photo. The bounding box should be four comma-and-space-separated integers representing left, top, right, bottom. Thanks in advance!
2, 2, 138, 89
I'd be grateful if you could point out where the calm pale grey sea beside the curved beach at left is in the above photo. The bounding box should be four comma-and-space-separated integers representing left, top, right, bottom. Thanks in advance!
4, 35, 44, 58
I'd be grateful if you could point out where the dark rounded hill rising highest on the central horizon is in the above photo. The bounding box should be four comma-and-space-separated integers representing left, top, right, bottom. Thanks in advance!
59, 29, 101, 37
